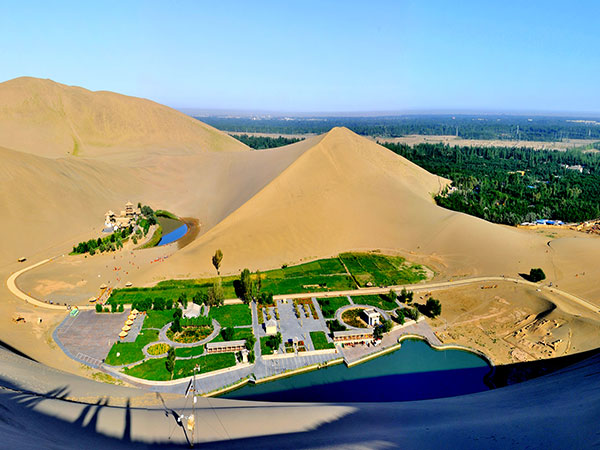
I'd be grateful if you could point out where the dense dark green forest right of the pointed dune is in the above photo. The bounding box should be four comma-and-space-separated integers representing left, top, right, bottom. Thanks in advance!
382, 143, 600, 225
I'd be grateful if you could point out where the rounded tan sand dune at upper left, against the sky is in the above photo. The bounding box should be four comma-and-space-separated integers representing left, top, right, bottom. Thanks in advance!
0, 77, 247, 158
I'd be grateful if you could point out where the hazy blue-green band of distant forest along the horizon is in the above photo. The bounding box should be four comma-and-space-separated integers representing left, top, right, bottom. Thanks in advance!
198, 114, 600, 141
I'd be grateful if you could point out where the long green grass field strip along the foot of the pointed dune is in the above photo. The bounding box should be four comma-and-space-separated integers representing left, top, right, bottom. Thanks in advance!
110, 253, 427, 304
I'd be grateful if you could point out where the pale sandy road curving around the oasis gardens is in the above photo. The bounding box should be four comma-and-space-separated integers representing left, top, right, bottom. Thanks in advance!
6, 258, 600, 314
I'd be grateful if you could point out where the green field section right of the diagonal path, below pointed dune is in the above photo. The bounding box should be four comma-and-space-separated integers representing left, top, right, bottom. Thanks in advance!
340, 253, 427, 287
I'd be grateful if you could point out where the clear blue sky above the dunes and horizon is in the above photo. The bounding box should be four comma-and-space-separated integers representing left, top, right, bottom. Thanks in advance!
0, 0, 600, 112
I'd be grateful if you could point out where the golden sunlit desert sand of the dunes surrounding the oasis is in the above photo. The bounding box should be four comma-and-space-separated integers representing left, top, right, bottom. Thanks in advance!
0, 78, 600, 447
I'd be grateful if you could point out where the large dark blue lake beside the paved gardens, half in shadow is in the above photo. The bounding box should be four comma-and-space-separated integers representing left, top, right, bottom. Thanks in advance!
221, 340, 490, 402
